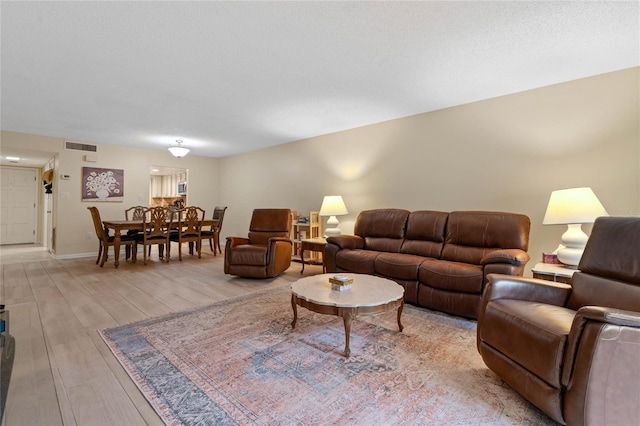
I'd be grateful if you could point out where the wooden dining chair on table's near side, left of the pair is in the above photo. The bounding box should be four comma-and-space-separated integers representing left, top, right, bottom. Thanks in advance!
136, 207, 174, 265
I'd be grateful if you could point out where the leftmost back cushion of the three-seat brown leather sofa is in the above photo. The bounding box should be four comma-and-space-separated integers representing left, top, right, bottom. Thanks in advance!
353, 209, 409, 253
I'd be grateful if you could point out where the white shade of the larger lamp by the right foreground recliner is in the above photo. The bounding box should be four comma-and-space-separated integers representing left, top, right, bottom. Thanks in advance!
542, 188, 609, 225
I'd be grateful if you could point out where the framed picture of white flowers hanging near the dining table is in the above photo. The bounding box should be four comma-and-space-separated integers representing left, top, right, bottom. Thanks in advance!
82, 167, 124, 202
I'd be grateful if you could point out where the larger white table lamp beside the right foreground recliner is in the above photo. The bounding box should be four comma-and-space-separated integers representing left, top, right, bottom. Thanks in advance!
542, 188, 609, 268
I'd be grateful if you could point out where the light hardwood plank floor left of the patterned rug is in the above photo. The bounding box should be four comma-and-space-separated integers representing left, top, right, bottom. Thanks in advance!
0, 245, 314, 426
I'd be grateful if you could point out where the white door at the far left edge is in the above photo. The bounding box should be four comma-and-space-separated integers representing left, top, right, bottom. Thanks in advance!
0, 167, 37, 244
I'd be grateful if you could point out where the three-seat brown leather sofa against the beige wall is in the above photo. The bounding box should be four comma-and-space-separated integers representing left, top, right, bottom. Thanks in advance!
324, 209, 531, 318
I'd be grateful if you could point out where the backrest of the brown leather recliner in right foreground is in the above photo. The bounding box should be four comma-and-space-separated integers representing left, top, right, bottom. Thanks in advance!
567, 217, 640, 312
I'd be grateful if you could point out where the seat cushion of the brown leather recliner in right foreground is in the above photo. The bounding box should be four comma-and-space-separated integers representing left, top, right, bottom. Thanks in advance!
480, 299, 576, 389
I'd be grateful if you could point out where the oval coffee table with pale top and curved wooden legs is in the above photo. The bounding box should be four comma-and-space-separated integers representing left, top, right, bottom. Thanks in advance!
291, 274, 404, 357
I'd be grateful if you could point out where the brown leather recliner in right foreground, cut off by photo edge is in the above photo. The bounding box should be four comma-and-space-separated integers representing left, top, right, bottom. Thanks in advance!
477, 217, 640, 425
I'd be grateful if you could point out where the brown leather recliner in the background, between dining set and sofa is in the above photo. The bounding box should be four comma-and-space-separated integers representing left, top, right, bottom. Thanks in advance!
224, 209, 292, 278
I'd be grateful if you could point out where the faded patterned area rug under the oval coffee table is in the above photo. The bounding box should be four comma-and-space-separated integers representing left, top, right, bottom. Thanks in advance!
100, 286, 555, 425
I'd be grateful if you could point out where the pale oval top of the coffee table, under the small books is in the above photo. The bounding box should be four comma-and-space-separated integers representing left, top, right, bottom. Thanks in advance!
291, 273, 404, 308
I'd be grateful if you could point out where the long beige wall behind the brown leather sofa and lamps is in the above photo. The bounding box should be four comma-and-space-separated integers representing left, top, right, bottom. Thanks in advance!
220, 68, 640, 268
